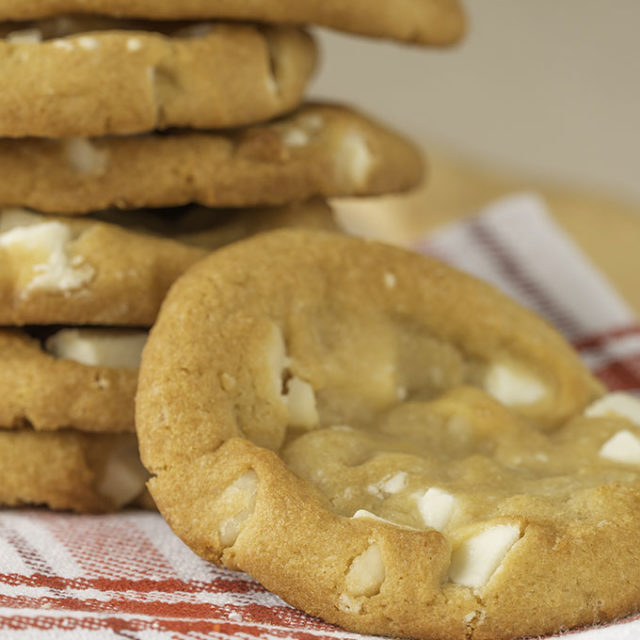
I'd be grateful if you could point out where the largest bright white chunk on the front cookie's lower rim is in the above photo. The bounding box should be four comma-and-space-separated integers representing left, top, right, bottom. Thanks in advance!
449, 524, 520, 589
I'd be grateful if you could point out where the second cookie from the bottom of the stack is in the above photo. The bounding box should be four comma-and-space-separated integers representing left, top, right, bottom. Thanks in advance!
0, 328, 142, 433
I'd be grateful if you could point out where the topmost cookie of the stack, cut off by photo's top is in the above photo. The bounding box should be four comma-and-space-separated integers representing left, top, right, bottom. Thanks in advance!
0, 0, 465, 45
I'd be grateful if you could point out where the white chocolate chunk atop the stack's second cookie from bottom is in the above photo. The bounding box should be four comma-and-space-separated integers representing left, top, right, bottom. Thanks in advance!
45, 329, 148, 369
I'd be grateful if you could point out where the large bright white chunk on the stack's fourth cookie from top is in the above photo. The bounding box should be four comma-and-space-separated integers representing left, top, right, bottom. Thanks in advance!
0, 222, 94, 293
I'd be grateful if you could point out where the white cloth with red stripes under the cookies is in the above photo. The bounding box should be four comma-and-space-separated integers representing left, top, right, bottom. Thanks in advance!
0, 195, 640, 640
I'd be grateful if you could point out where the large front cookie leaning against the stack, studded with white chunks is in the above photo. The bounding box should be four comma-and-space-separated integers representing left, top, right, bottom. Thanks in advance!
136, 231, 640, 640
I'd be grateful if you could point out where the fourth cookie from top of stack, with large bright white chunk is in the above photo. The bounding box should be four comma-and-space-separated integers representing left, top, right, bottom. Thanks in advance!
0, 203, 338, 327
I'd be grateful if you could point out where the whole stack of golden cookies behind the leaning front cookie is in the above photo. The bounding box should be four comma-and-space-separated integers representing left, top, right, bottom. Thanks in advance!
0, 0, 462, 511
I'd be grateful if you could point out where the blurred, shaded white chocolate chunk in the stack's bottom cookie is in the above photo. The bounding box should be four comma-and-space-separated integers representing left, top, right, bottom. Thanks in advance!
96, 445, 149, 508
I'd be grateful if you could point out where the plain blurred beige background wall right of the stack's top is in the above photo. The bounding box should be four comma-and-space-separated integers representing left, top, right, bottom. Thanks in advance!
314, 0, 640, 203
